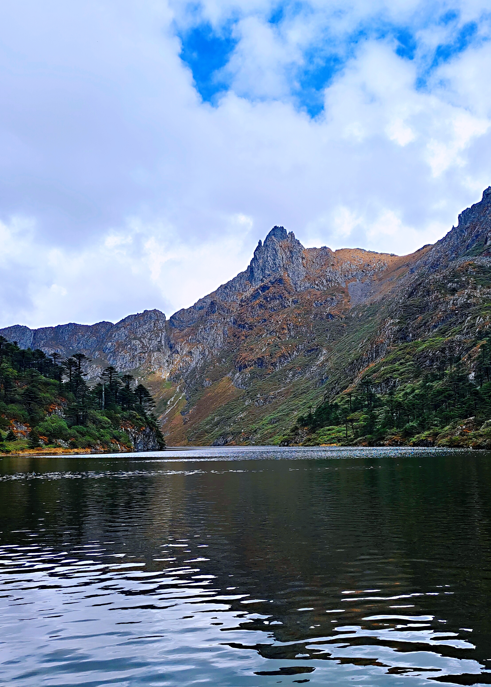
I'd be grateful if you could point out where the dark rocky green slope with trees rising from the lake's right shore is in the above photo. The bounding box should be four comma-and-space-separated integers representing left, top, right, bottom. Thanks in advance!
283, 259, 491, 448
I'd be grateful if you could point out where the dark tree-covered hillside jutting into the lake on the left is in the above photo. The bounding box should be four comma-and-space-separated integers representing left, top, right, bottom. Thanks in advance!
0, 336, 165, 453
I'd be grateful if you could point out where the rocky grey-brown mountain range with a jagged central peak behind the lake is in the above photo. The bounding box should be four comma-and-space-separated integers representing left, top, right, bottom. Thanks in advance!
0, 188, 491, 445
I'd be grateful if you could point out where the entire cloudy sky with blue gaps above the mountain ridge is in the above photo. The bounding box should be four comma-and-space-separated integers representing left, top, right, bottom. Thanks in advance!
0, 0, 491, 327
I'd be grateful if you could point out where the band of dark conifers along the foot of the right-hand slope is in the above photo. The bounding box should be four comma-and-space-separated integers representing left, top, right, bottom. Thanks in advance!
294, 340, 491, 442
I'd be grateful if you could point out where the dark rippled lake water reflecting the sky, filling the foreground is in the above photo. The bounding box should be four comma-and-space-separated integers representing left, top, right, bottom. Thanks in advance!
0, 449, 491, 687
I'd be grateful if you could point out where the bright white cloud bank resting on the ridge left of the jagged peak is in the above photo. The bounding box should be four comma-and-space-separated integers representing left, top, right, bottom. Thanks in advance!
0, 210, 252, 326
